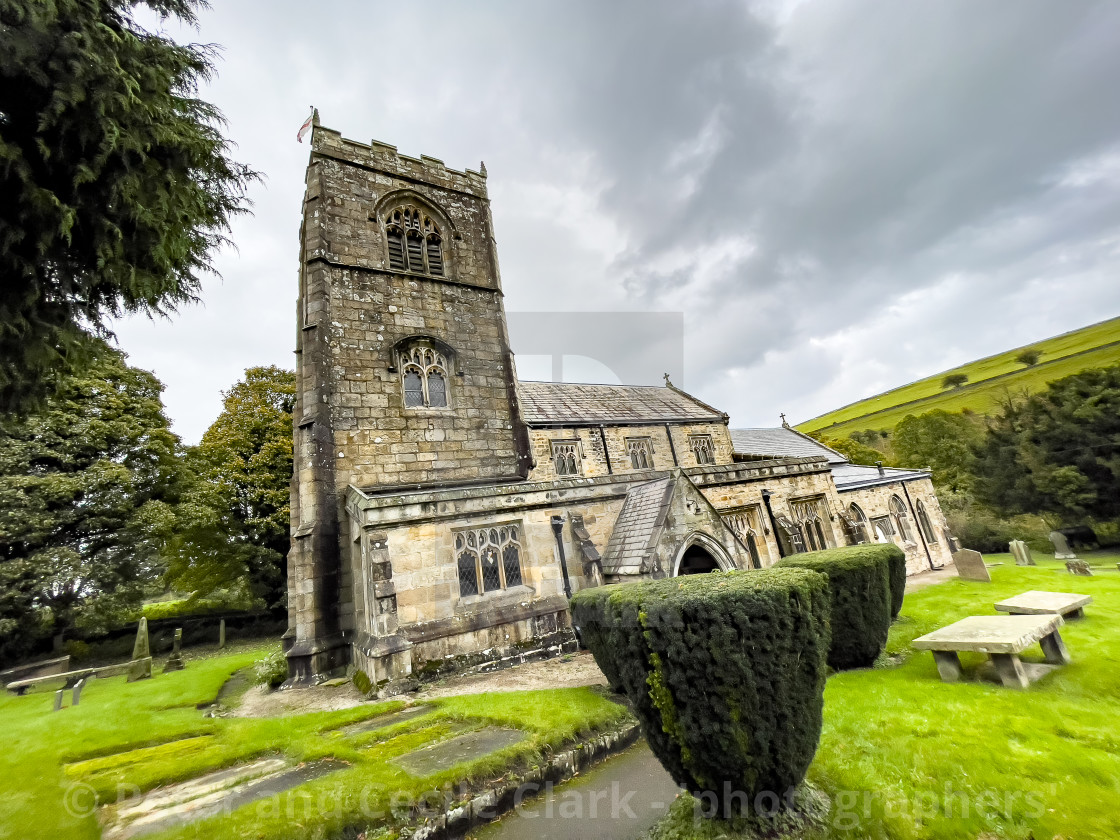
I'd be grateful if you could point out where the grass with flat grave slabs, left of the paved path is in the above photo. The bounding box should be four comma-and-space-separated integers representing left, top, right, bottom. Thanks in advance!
0, 646, 627, 840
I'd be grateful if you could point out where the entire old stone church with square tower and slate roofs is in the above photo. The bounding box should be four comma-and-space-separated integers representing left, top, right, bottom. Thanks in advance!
284, 119, 950, 684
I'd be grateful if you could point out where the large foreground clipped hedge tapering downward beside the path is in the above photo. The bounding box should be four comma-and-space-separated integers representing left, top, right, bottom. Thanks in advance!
572, 569, 829, 815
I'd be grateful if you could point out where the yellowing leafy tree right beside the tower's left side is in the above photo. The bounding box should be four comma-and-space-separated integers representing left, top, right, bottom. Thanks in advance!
169, 367, 296, 607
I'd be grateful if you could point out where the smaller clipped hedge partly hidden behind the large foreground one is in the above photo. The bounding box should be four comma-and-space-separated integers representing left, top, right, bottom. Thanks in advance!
775, 544, 891, 671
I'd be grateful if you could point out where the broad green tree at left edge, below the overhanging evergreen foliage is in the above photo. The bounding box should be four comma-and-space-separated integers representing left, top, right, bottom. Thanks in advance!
0, 342, 180, 660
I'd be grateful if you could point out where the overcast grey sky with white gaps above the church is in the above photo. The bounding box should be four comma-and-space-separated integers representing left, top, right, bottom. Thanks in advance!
118, 0, 1120, 442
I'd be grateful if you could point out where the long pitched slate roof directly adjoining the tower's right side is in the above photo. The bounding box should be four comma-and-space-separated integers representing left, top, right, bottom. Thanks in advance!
517, 382, 727, 426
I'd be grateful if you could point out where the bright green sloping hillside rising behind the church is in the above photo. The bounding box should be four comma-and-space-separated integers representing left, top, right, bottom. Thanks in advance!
797, 318, 1120, 438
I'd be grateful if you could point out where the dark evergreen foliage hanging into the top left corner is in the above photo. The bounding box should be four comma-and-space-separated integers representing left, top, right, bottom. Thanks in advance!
0, 0, 256, 411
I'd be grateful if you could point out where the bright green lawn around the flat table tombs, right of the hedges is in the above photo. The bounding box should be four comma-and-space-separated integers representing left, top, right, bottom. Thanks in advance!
657, 552, 1120, 840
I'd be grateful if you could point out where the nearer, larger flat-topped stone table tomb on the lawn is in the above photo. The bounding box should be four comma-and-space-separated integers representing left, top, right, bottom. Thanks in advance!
913, 613, 1070, 689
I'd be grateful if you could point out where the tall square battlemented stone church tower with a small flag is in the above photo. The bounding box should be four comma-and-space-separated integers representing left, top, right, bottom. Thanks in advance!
286, 115, 530, 682
